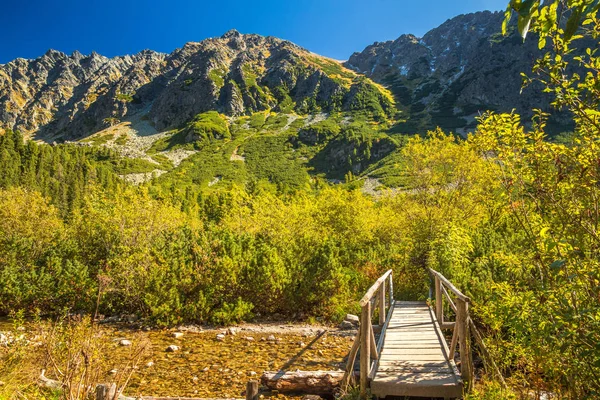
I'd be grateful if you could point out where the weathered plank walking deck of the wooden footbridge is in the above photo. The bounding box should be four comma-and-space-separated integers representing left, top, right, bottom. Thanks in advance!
371, 301, 463, 398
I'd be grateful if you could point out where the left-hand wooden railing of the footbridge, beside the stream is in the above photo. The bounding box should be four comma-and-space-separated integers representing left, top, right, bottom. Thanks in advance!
341, 269, 394, 399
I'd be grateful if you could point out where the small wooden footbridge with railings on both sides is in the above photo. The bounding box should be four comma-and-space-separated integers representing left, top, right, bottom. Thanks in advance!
342, 270, 503, 399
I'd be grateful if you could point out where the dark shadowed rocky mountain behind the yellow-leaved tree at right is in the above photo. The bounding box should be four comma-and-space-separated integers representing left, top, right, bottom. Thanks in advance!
345, 11, 569, 133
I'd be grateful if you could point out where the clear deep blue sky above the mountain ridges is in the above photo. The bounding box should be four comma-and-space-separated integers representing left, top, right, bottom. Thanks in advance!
0, 0, 508, 63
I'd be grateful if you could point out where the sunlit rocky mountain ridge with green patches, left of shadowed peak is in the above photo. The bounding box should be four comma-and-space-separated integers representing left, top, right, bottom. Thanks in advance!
0, 30, 394, 141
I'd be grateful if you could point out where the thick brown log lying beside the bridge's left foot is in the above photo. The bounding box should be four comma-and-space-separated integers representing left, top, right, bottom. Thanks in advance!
260, 371, 344, 395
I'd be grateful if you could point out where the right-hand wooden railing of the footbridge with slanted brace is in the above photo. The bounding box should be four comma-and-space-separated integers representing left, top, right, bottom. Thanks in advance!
429, 268, 506, 390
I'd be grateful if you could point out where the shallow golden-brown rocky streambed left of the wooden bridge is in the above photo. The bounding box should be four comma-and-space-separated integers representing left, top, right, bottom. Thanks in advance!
0, 323, 356, 398
